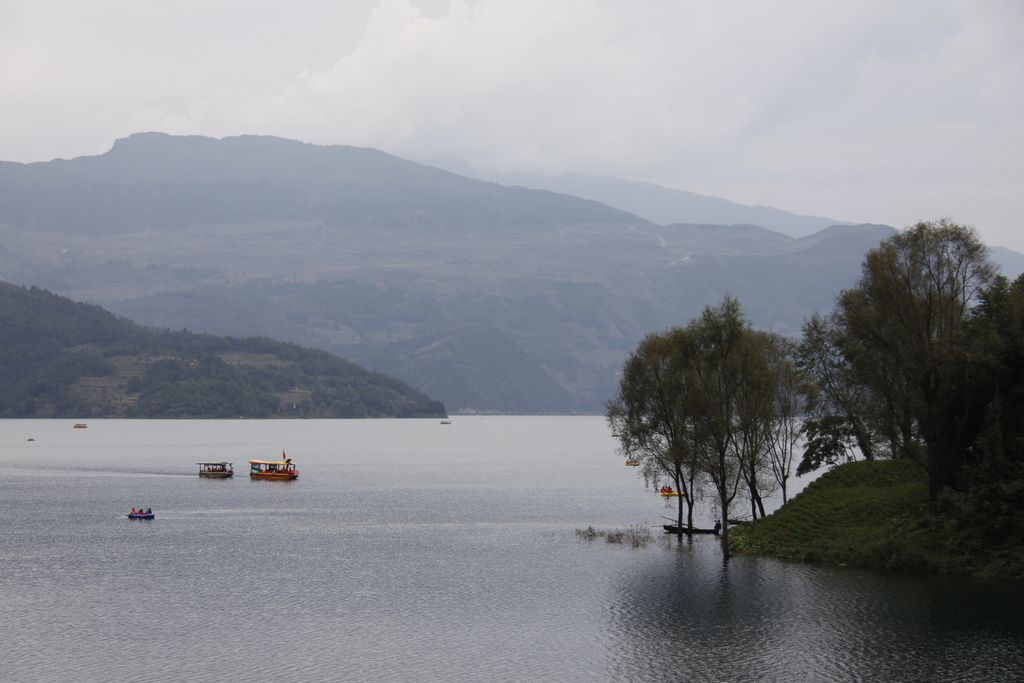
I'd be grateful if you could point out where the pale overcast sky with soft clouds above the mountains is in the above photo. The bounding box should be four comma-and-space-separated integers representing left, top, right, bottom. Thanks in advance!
0, 0, 1024, 251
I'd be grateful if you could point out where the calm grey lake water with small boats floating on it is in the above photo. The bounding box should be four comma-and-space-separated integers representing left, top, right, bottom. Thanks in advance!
0, 417, 1024, 681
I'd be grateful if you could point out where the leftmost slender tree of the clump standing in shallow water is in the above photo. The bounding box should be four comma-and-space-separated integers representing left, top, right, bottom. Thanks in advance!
605, 329, 697, 526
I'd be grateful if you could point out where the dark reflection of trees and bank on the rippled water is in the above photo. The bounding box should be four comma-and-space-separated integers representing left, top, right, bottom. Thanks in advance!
609, 539, 1024, 681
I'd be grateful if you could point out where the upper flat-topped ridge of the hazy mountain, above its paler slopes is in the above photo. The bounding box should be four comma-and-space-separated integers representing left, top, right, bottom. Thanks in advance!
0, 133, 638, 233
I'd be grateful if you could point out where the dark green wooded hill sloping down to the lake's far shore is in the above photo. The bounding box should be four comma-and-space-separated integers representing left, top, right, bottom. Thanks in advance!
0, 283, 444, 418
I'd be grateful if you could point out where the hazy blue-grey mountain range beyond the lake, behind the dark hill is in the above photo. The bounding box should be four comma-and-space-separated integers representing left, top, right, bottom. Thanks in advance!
0, 133, 1020, 413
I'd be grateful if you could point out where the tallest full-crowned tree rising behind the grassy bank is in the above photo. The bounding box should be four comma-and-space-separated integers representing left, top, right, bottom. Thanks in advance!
837, 219, 994, 501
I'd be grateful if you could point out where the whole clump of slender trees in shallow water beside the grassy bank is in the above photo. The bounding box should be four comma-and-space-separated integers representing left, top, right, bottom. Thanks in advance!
606, 297, 803, 554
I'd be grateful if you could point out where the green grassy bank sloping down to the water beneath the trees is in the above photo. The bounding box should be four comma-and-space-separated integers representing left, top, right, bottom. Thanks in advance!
729, 461, 1024, 579
